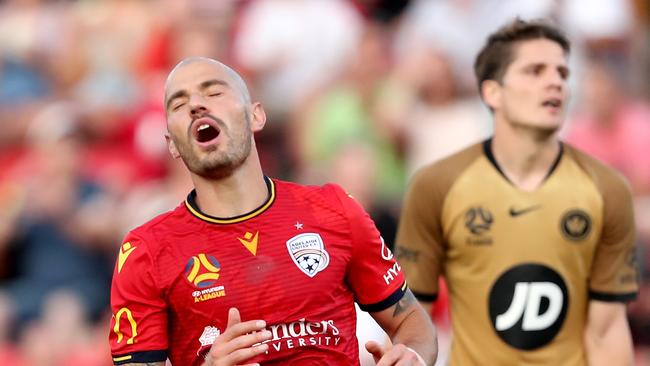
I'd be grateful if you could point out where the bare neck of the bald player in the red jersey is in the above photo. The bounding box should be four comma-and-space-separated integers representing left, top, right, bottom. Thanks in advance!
192, 152, 269, 217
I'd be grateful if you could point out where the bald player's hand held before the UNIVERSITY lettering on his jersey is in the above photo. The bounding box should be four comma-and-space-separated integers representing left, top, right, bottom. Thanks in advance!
203, 308, 271, 366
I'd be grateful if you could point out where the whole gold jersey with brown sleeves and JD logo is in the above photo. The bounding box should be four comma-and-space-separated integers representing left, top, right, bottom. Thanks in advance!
396, 140, 637, 366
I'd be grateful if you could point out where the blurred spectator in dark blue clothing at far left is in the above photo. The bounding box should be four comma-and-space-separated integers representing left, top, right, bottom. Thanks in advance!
0, 103, 115, 332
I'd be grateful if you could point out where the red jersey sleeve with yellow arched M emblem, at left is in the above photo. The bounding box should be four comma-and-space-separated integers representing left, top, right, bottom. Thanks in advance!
109, 234, 168, 365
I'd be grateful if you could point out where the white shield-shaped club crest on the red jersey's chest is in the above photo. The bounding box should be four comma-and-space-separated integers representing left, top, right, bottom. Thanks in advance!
287, 233, 330, 277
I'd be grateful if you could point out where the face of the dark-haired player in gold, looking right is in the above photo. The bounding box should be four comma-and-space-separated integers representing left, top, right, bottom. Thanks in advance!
486, 39, 569, 132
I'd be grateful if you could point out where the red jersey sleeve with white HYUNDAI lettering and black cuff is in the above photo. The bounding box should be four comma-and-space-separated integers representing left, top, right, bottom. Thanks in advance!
331, 185, 406, 312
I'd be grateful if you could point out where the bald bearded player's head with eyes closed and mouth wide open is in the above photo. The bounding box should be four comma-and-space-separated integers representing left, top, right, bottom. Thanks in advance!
165, 60, 261, 178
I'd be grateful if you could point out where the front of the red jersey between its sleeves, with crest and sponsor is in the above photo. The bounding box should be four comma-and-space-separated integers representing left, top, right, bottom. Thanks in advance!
161, 202, 355, 360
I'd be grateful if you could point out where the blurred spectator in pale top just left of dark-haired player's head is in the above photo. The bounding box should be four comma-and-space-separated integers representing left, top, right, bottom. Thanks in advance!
377, 44, 492, 175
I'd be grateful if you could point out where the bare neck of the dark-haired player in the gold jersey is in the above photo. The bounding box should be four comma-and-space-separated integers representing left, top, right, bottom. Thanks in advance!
492, 123, 560, 191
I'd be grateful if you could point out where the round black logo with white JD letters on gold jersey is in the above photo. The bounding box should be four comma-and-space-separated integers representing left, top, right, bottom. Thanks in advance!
489, 263, 569, 350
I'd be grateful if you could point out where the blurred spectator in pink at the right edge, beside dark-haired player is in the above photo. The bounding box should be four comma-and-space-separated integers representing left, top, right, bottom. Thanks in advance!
565, 57, 650, 195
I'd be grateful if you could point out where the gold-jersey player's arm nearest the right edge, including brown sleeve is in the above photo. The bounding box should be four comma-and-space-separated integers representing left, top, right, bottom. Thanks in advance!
584, 169, 638, 366
